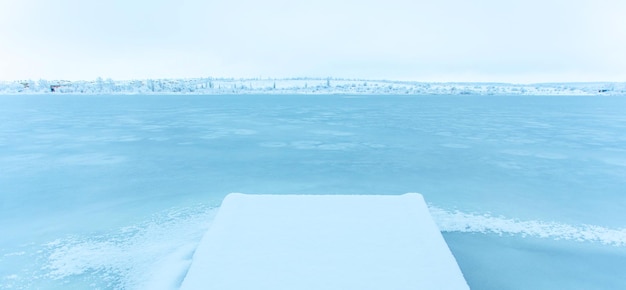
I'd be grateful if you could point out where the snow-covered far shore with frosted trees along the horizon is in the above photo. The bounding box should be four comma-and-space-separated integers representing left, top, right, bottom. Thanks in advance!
0, 78, 626, 95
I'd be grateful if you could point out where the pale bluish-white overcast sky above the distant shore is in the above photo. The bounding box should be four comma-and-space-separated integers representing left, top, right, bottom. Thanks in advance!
0, 0, 626, 83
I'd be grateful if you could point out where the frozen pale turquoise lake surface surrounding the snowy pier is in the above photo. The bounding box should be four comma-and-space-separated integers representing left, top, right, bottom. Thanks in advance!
0, 95, 626, 289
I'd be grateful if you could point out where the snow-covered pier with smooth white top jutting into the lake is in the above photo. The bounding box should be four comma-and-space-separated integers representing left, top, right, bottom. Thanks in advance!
181, 193, 469, 290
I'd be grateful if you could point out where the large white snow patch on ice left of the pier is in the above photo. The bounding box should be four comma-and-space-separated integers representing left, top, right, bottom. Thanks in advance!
43, 206, 216, 289
